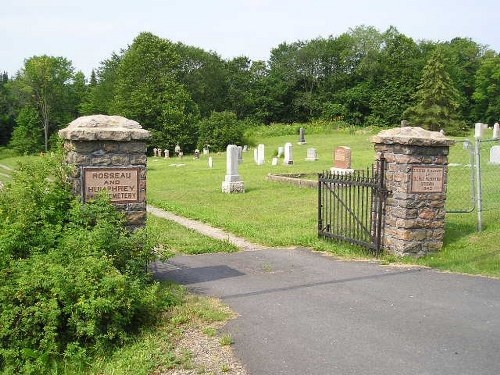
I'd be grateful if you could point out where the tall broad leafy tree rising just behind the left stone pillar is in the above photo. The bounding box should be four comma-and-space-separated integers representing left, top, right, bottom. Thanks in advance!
110, 33, 199, 152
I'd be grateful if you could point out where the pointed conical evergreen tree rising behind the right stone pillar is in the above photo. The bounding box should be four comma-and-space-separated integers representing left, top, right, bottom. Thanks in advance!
404, 48, 464, 134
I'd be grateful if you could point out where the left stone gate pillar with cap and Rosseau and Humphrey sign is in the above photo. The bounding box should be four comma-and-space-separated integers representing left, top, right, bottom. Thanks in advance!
59, 115, 150, 229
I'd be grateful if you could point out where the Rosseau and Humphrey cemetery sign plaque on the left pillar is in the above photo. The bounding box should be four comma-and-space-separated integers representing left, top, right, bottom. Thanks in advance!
82, 168, 139, 203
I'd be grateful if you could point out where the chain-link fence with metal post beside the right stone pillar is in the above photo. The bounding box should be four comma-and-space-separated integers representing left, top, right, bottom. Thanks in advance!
446, 135, 500, 230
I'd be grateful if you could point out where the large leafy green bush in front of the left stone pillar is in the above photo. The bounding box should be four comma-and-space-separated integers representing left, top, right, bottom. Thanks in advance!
0, 156, 170, 373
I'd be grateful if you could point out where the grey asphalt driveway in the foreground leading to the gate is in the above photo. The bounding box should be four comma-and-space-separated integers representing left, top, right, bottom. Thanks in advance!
153, 249, 500, 375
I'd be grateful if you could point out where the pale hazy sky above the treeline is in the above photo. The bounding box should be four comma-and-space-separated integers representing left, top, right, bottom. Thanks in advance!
0, 0, 500, 77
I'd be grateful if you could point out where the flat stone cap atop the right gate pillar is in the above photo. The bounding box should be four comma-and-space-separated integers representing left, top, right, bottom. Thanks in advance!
371, 127, 455, 147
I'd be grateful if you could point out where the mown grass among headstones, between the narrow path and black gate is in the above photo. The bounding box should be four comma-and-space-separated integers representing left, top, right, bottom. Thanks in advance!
148, 133, 375, 253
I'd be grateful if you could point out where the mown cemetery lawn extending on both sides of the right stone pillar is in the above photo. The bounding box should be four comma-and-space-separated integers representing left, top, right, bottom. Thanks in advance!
148, 127, 500, 277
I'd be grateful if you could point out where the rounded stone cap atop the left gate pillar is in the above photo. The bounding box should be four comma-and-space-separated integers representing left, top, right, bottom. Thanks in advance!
59, 115, 151, 142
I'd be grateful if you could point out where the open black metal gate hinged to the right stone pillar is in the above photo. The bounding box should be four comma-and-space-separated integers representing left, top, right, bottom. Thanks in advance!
318, 158, 387, 254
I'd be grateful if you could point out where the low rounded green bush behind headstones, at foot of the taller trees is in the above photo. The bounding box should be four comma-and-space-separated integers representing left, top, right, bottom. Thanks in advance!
198, 111, 247, 151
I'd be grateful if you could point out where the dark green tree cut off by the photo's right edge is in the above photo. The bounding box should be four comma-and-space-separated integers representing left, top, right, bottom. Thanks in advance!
472, 54, 500, 124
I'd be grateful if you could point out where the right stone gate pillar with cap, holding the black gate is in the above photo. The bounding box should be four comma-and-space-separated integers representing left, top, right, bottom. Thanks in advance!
372, 127, 454, 256
